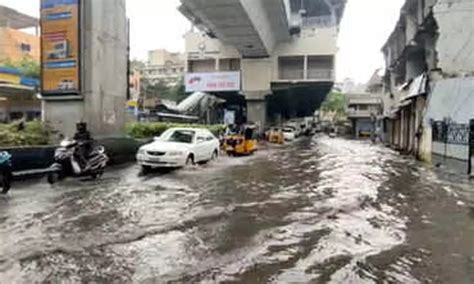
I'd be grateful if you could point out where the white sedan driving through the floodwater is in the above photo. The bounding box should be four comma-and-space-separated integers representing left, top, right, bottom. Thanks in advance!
137, 128, 219, 171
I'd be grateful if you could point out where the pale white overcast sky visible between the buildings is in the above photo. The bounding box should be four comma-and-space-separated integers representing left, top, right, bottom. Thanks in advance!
0, 0, 404, 83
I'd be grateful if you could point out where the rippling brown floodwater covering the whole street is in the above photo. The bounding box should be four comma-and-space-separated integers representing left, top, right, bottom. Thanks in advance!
0, 136, 474, 283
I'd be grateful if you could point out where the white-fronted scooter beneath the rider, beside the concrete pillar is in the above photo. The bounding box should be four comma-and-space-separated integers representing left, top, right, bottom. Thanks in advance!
48, 140, 109, 184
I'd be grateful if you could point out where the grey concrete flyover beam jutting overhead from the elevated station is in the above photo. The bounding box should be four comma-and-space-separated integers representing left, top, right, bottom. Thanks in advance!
179, 0, 290, 58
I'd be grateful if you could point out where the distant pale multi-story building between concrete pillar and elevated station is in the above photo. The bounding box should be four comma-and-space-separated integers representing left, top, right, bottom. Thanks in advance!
143, 49, 185, 86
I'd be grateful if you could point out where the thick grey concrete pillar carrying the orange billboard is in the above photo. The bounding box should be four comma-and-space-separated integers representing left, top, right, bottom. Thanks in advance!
43, 0, 128, 136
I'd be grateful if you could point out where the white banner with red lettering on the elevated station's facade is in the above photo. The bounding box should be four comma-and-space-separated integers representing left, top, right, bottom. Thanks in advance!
185, 71, 240, 93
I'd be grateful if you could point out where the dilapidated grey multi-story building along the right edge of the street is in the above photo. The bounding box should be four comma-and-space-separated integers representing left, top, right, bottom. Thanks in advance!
382, 0, 474, 173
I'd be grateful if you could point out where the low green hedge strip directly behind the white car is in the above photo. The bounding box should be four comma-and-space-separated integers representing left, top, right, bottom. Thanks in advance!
126, 122, 225, 139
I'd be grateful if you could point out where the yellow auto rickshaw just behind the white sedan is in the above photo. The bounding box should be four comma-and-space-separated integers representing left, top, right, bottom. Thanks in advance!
223, 125, 258, 156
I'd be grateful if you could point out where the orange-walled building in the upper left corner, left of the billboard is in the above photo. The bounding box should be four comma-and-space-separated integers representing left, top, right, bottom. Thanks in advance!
0, 6, 40, 61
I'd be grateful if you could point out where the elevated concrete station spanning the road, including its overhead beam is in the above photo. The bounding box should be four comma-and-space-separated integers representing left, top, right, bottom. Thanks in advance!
179, 0, 346, 128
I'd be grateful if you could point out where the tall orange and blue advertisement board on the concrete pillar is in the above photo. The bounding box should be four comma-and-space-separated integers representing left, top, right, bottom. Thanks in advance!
41, 0, 80, 95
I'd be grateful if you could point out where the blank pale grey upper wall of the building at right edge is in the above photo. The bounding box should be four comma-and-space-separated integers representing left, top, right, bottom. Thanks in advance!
434, 0, 474, 74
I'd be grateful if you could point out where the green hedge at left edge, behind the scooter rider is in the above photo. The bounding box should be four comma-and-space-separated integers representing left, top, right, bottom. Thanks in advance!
0, 121, 52, 147
